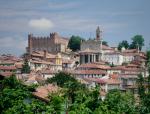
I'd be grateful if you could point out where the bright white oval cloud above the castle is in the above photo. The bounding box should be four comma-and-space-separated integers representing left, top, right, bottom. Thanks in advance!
29, 18, 54, 30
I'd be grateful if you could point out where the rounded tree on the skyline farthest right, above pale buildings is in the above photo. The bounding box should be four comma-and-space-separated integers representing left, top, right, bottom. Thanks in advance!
130, 35, 144, 50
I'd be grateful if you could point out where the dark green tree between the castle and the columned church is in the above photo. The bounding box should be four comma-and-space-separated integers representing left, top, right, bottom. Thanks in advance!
68, 35, 83, 51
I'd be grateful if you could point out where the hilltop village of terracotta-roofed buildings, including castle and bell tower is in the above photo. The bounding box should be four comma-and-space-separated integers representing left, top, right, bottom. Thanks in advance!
0, 27, 148, 99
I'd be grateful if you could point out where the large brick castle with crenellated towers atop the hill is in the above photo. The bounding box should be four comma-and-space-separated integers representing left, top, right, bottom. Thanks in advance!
27, 32, 69, 54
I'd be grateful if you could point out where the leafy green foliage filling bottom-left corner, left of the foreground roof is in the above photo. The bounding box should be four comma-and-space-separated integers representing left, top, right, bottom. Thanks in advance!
0, 76, 46, 114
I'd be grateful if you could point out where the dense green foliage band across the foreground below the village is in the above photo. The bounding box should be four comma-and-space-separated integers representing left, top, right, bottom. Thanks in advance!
0, 72, 150, 114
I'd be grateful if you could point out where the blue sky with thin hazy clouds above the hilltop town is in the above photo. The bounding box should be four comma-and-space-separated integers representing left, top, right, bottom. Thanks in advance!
0, 0, 150, 56
